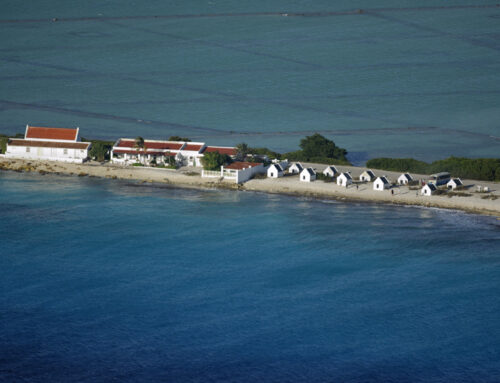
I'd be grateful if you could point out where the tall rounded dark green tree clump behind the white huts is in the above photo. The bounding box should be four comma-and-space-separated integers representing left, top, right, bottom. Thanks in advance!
281, 133, 350, 165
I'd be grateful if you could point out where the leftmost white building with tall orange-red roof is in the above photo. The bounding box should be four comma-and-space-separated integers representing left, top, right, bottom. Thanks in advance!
5, 125, 91, 163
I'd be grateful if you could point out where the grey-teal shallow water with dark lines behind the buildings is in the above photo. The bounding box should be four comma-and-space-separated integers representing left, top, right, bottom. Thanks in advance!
0, 0, 500, 163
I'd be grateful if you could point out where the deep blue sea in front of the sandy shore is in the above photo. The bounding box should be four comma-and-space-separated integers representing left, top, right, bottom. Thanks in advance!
0, 172, 500, 382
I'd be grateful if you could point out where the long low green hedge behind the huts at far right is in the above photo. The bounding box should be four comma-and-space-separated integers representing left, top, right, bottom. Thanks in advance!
366, 157, 500, 181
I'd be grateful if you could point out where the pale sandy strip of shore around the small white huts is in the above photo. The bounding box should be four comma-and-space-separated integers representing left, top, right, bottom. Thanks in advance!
0, 157, 500, 217
